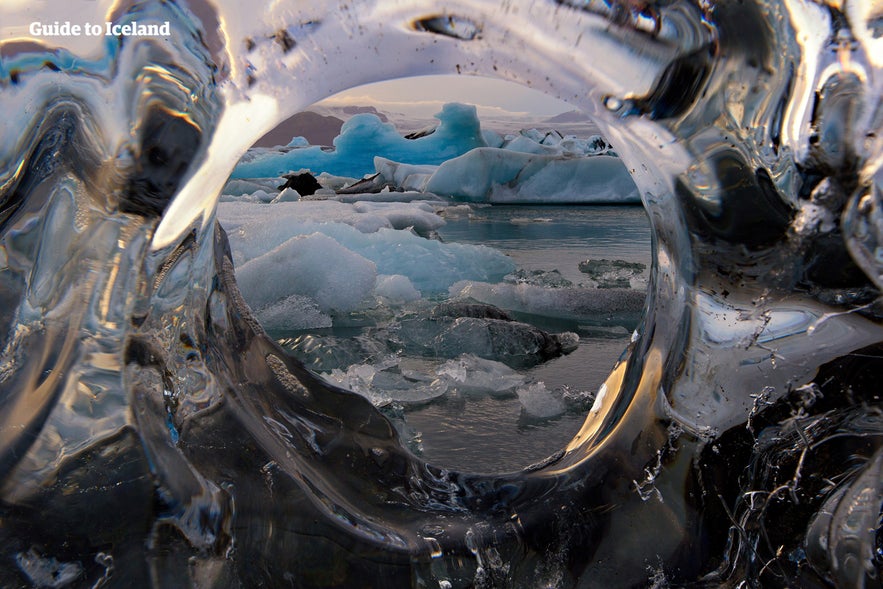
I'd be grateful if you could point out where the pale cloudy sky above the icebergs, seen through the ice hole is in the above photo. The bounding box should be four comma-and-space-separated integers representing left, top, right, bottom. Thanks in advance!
320, 76, 574, 118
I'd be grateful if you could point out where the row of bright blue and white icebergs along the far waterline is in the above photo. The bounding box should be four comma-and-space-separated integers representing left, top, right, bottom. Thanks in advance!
225, 103, 640, 204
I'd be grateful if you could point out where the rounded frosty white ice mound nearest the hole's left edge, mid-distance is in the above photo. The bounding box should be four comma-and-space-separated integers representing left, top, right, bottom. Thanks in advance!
236, 233, 377, 312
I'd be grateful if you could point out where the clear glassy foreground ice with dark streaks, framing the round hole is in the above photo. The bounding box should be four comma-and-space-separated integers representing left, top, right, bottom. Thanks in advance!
0, 0, 883, 587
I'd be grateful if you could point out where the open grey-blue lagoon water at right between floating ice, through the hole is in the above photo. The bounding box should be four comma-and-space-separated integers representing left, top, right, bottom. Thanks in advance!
407, 206, 650, 472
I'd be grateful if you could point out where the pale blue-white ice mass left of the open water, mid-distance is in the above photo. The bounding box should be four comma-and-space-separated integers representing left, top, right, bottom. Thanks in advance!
218, 201, 514, 330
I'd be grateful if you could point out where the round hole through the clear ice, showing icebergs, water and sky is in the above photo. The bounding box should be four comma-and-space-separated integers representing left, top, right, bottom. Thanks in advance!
219, 76, 651, 472
